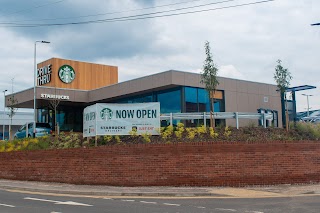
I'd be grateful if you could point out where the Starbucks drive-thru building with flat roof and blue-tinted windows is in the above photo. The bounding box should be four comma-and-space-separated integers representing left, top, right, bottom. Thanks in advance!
6, 58, 282, 132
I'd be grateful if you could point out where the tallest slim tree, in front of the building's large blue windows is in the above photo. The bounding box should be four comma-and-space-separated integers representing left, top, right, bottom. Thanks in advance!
200, 41, 219, 127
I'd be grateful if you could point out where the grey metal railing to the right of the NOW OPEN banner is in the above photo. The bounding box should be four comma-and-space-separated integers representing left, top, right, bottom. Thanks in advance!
160, 112, 273, 129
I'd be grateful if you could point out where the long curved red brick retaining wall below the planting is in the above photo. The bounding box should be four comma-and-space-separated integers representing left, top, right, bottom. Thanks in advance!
0, 142, 320, 186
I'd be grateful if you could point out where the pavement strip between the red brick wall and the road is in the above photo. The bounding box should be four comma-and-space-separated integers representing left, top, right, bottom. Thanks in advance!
0, 179, 320, 198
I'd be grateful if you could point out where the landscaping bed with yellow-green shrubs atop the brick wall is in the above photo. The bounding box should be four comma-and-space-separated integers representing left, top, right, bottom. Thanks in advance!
0, 122, 320, 152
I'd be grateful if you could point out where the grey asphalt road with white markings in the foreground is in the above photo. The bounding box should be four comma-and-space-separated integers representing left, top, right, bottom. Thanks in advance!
0, 190, 320, 213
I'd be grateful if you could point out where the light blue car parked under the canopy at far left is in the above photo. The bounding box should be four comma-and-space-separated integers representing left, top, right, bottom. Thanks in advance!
14, 122, 52, 139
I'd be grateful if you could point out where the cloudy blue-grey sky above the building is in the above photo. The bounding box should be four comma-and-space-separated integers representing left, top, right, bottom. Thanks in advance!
0, 0, 320, 111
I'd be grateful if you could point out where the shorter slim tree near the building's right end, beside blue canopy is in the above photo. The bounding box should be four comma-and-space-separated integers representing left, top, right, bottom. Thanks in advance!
273, 59, 292, 131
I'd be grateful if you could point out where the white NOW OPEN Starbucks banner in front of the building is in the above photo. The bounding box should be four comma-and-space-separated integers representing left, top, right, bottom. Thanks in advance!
83, 102, 160, 137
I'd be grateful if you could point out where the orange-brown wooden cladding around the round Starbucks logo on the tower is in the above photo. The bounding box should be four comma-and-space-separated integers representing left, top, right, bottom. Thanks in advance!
38, 58, 118, 90
